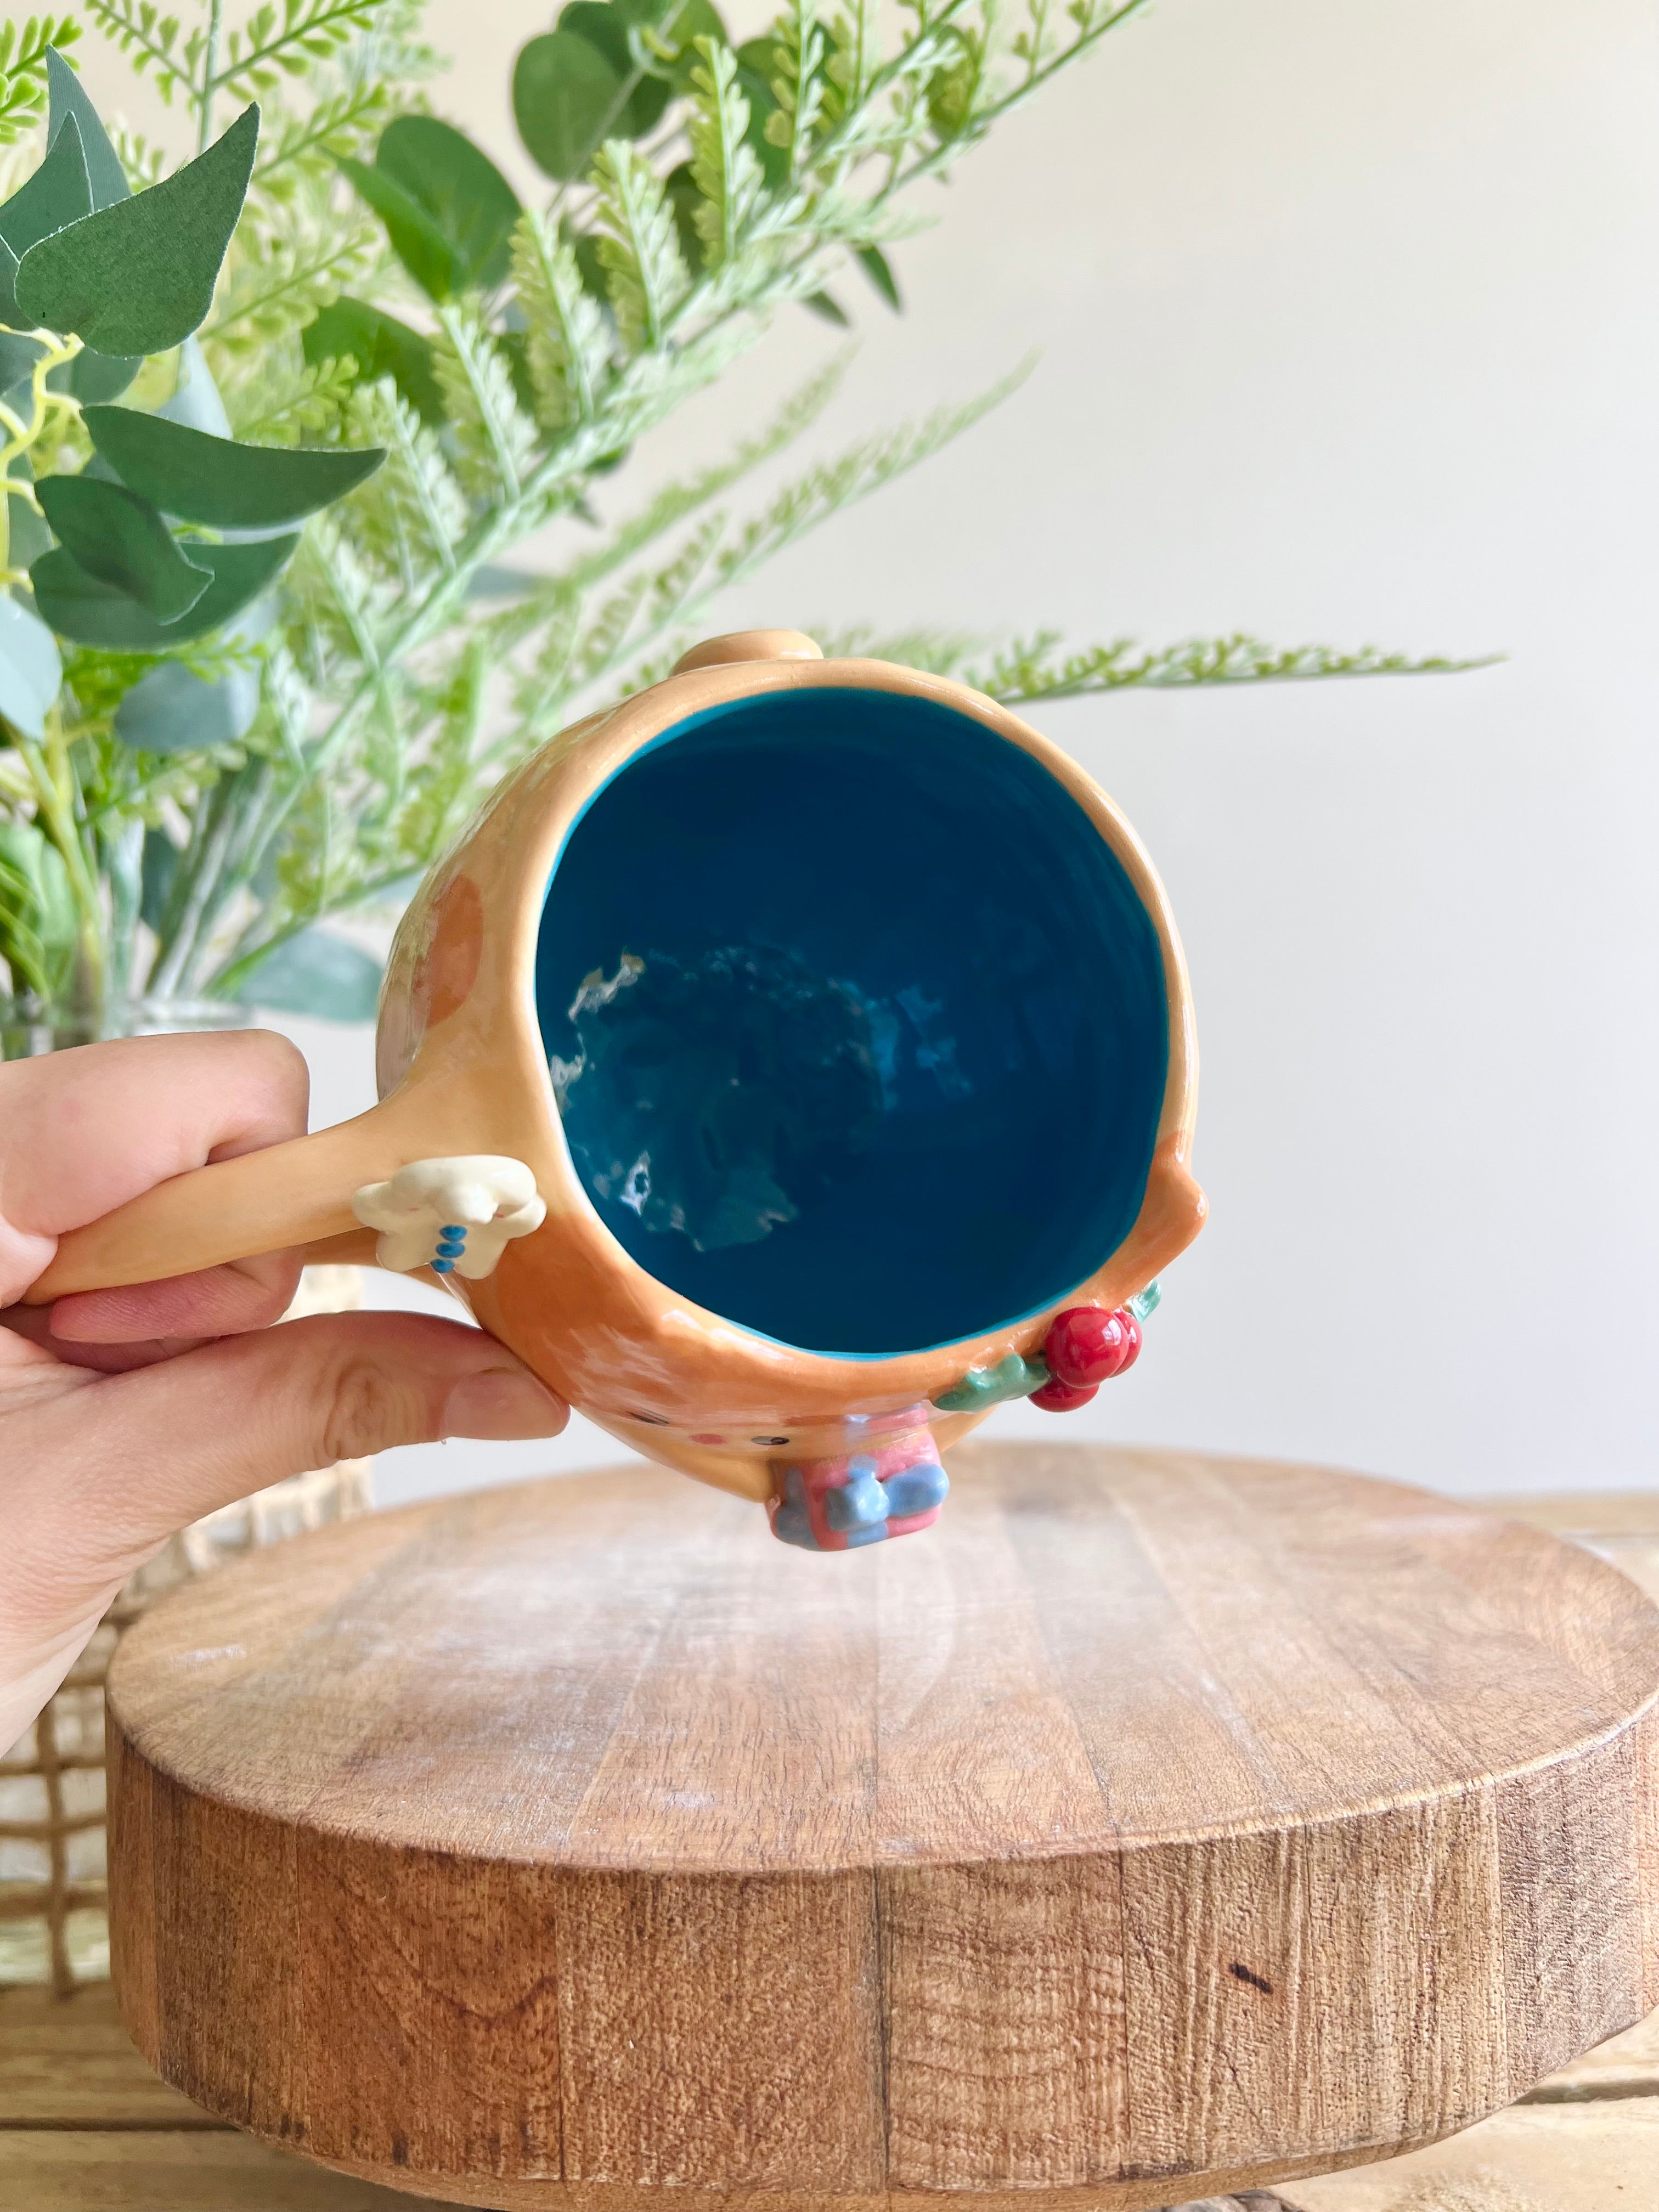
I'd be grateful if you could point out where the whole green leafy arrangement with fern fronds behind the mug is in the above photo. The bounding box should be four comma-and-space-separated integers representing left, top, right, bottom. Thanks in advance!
0, 0, 1477, 1020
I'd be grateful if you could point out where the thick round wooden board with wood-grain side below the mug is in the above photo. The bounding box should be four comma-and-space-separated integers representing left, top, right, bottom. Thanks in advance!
111, 1447, 1659, 2212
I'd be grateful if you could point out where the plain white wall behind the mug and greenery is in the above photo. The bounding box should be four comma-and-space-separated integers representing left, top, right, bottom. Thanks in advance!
88, 0, 1659, 1502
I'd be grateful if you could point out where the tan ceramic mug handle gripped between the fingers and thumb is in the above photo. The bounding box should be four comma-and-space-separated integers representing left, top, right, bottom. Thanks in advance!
22, 1091, 438, 1305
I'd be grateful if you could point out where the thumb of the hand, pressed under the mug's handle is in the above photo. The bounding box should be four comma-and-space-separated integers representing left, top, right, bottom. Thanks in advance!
0, 1314, 568, 1633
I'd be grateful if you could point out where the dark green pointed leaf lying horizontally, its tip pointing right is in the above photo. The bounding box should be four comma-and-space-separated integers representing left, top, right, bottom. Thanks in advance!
84, 407, 385, 531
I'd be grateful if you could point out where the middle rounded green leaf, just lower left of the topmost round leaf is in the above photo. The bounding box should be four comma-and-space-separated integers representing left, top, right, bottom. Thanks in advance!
358, 115, 520, 298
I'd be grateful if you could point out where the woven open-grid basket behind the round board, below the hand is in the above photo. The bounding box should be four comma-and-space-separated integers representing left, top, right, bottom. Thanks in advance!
0, 1267, 374, 1997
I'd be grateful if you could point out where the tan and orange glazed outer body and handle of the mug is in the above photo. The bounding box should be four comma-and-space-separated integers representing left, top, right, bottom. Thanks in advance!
29, 630, 1203, 1517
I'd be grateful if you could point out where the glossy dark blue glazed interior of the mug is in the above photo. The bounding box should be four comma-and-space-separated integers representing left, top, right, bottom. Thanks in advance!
535, 686, 1170, 1358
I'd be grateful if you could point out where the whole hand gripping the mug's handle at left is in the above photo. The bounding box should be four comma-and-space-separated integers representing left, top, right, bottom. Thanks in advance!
0, 1029, 568, 1750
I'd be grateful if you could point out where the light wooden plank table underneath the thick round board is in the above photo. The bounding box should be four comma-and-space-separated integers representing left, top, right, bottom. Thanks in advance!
0, 1469, 1659, 2212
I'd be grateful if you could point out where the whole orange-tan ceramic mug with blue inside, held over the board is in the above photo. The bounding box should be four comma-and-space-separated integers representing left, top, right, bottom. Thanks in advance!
29, 630, 1203, 1550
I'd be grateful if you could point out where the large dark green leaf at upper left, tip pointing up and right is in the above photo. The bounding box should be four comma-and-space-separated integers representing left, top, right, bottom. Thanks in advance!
15, 106, 259, 354
